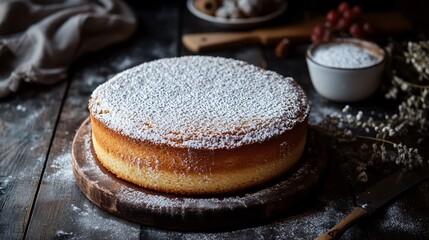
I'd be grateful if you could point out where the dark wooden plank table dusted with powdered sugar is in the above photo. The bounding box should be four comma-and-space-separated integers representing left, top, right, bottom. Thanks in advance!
0, 1, 429, 239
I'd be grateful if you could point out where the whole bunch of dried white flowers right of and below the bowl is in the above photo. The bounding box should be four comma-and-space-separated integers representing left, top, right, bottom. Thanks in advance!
319, 41, 429, 182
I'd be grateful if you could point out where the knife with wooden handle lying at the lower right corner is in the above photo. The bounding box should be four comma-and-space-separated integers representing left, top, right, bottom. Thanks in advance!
316, 166, 429, 240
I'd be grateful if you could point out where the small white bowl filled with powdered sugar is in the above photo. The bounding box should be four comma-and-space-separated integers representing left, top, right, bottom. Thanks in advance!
306, 38, 385, 102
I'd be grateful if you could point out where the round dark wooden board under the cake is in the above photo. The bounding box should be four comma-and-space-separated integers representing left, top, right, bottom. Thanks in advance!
72, 119, 327, 230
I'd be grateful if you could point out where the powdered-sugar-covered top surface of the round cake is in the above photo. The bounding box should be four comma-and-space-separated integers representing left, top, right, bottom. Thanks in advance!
89, 56, 310, 149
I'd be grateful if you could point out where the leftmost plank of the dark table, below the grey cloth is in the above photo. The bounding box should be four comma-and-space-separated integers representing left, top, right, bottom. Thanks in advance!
0, 82, 67, 239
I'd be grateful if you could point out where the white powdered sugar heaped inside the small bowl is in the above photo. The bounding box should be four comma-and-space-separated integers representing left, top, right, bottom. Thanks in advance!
313, 43, 381, 69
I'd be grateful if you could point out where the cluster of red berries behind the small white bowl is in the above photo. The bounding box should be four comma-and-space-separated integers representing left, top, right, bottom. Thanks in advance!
311, 2, 375, 43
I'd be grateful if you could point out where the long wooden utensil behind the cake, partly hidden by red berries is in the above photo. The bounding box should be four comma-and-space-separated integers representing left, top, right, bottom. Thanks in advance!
182, 12, 413, 53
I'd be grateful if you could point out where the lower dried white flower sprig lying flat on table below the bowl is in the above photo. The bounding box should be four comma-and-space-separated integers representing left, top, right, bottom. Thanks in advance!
319, 105, 424, 182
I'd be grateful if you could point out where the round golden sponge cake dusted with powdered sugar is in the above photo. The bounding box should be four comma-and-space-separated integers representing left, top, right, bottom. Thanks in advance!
89, 56, 310, 194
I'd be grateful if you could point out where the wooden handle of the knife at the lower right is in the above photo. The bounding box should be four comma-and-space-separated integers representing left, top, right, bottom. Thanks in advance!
315, 207, 368, 240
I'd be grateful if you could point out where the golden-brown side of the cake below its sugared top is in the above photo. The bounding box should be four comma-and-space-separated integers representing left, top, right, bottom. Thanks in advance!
91, 115, 307, 194
